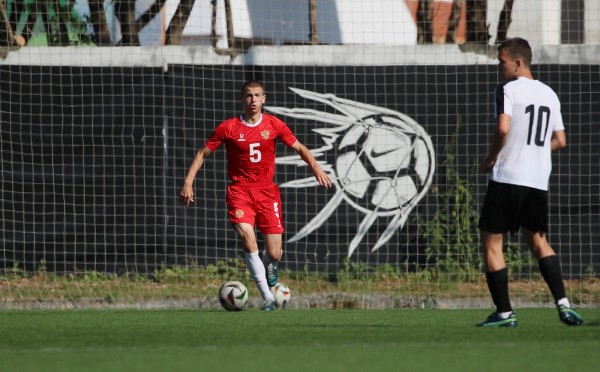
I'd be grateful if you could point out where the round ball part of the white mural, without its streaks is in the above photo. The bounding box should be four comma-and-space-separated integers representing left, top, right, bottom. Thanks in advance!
335, 115, 433, 215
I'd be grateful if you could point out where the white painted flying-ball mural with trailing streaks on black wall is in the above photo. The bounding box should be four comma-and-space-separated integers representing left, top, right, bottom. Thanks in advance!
266, 88, 435, 257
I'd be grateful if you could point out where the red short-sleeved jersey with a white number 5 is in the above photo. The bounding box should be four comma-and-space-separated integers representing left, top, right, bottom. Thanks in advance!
204, 114, 297, 183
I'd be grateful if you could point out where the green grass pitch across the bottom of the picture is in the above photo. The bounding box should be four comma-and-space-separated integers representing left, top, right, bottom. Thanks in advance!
0, 308, 600, 372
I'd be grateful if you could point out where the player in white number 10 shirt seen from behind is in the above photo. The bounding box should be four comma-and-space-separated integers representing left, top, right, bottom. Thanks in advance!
477, 38, 583, 327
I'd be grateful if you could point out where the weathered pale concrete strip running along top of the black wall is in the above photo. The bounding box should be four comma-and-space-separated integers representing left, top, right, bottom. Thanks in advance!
0, 44, 600, 69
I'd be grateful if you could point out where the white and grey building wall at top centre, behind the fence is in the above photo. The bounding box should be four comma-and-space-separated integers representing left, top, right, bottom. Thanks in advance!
183, 0, 417, 47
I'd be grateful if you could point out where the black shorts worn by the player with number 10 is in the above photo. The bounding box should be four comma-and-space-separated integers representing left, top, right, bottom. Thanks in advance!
479, 181, 548, 234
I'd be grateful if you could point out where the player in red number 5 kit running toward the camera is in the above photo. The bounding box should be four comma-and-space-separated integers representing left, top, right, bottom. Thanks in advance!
179, 80, 332, 310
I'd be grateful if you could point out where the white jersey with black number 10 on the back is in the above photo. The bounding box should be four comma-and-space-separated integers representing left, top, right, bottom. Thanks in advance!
490, 77, 565, 190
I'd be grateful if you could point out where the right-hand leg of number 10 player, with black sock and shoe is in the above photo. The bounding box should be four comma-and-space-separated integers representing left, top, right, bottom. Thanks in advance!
523, 228, 583, 325
